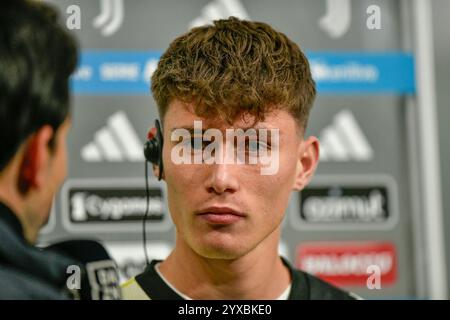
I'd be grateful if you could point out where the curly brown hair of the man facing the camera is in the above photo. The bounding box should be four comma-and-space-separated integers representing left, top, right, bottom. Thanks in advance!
151, 17, 316, 129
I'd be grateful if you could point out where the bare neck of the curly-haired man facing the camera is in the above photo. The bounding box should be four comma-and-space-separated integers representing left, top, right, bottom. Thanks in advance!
159, 234, 291, 299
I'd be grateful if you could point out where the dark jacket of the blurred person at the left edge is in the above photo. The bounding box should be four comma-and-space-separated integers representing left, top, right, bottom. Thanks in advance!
0, 203, 73, 300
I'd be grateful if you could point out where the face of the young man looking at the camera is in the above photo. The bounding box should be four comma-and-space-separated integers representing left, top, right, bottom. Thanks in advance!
163, 100, 316, 259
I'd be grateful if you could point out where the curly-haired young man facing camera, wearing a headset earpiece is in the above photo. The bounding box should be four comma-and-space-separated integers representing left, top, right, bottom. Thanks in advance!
123, 17, 355, 300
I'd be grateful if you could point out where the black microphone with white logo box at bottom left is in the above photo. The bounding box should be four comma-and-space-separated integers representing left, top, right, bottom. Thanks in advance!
44, 240, 122, 300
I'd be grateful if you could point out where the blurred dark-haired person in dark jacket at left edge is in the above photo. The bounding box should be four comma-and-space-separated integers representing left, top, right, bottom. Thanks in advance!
0, 0, 77, 299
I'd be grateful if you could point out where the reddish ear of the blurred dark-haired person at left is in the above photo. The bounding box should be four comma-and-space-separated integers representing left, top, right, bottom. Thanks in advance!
19, 125, 54, 192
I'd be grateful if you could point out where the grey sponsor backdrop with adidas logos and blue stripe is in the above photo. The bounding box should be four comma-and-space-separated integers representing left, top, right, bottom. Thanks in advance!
41, 0, 430, 298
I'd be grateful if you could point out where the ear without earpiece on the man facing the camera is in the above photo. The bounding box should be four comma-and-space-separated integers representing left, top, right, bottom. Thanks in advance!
293, 137, 319, 191
